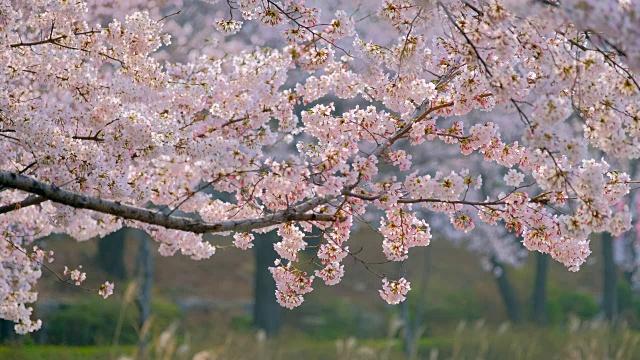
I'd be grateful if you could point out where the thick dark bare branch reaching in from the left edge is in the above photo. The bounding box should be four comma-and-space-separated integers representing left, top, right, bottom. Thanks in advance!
0, 171, 336, 234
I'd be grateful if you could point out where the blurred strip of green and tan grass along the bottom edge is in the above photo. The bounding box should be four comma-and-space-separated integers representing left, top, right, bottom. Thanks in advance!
0, 320, 640, 360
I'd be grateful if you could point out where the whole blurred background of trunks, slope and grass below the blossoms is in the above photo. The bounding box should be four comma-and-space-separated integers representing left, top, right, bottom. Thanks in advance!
0, 226, 640, 360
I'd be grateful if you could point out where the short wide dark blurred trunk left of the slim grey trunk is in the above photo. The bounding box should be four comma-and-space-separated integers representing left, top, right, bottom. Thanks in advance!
96, 228, 129, 280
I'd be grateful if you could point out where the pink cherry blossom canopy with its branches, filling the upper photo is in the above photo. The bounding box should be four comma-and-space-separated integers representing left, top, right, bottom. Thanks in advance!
0, 0, 640, 333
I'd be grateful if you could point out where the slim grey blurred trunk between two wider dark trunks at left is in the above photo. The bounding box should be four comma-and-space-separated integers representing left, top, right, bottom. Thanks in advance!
137, 236, 153, 358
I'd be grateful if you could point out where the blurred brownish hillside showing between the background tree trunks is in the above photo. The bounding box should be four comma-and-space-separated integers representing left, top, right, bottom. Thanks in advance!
33, 228, 602, 330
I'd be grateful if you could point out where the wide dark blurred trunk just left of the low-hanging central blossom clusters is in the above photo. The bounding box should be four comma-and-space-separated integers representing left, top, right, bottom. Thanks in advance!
253, 231, 282, 336
